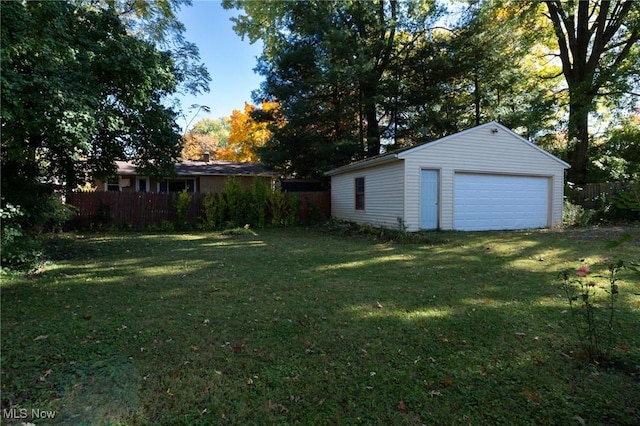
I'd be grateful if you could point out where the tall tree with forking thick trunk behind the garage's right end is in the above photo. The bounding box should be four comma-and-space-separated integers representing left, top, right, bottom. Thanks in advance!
545, 0, 640, 183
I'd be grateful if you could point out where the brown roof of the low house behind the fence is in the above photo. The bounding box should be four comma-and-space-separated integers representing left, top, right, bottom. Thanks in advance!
116, 160, 275, 176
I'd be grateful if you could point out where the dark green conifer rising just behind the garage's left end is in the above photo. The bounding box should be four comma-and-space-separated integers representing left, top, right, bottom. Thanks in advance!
252, 18, 364, 177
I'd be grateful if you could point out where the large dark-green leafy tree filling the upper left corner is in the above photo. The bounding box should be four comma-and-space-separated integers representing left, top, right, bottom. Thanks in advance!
0, 1, 181, 221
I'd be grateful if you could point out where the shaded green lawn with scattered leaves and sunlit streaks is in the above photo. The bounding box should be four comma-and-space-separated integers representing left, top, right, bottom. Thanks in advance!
2, 228, 640, 425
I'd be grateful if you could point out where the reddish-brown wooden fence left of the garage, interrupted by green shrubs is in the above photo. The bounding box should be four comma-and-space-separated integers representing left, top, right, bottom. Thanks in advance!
67, 191, 331, 229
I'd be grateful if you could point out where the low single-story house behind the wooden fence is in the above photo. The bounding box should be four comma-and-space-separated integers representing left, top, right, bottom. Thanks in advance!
94, 154, 276, 193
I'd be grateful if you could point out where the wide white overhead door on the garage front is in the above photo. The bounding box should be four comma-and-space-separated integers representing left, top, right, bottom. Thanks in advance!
453, 173, 549, 231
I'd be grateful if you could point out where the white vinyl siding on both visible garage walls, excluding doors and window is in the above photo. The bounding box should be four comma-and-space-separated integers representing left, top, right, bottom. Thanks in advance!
327, 122, 568, 232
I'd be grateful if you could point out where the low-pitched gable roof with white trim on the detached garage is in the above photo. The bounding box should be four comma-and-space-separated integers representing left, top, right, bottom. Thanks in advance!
325, 121, 571, 176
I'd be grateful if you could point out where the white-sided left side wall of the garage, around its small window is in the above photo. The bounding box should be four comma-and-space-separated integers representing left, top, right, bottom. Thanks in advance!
331, 161, 404, 228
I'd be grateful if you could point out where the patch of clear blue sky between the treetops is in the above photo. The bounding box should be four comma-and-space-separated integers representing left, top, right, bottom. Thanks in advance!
178, 0, 263, 128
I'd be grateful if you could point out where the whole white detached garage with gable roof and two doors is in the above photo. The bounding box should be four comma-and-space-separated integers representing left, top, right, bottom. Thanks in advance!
326, 122, 569, 231
